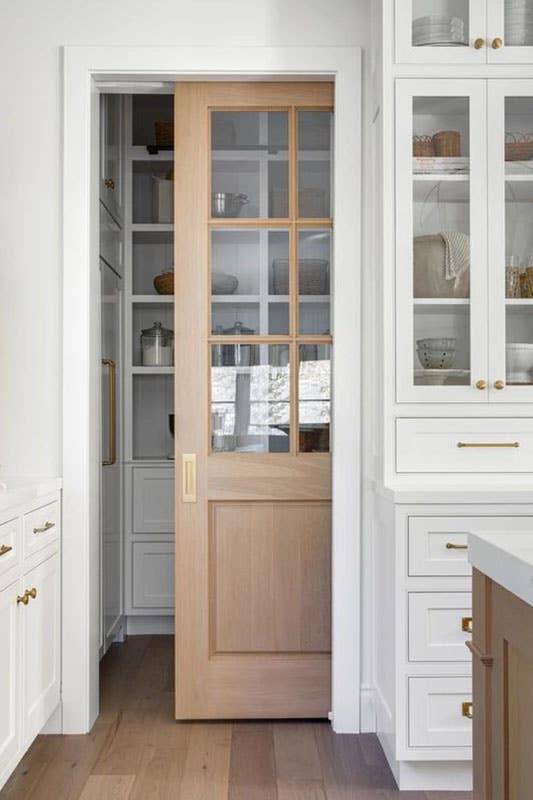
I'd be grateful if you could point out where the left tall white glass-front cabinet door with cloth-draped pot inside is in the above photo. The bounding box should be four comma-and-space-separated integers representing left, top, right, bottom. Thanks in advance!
396, 80, 488, 402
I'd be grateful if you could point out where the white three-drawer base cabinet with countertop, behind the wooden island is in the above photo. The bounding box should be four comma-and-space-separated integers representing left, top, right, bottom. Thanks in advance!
375, 490, 533, 797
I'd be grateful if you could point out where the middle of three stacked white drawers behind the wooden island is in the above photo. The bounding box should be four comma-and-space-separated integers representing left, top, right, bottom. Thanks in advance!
409, 592, 472, 661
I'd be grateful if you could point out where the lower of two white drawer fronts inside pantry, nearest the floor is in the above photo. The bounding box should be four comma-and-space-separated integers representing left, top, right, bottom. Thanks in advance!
133, 542, 174, 608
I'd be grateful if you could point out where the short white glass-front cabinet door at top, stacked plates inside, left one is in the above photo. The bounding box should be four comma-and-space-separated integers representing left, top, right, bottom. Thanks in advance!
395, 0, 487, 64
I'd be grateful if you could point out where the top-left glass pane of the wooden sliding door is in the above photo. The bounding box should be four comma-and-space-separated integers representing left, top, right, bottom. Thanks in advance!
211, 111, 289, 218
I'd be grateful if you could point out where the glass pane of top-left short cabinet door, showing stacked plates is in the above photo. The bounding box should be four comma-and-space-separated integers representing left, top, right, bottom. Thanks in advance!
412, 0, 470, 47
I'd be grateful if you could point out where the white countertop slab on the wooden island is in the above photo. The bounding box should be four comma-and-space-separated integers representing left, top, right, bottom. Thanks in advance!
468, 532, 533, 606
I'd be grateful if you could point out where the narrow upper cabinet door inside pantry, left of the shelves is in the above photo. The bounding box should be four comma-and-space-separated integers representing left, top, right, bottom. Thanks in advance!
100, 94, 124, 224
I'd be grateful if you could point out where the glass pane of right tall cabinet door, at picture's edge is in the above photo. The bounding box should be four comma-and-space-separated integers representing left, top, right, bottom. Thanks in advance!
505, 97, 533, 385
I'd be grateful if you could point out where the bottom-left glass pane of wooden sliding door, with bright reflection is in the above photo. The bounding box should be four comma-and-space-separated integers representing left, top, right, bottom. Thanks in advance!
211, 343, 290, 453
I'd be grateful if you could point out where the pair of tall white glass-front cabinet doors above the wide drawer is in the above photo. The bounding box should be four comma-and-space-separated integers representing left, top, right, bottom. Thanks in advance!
396, 79, 533, 404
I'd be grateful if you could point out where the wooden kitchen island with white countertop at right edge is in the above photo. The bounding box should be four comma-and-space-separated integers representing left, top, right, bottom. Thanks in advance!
463, 531, 533, 800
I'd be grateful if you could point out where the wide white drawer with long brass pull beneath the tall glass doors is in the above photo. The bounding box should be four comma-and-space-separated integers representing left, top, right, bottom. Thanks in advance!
396, 418, 533, 473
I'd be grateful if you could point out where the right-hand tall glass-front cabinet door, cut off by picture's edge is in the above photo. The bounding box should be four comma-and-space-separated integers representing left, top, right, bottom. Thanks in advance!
488, 80, 533, 402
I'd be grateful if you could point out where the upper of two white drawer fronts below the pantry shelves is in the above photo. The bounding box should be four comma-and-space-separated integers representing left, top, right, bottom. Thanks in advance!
133, 467, 174, 533
